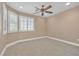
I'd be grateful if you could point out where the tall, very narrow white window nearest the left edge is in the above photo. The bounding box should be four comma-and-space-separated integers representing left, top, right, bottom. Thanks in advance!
3, 4, 7, 35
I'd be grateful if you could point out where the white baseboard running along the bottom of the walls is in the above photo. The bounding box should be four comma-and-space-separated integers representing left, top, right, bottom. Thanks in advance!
0, 36, 79, 56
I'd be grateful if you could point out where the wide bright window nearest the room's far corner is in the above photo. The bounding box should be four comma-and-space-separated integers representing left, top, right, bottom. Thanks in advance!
19, 16, 34, 31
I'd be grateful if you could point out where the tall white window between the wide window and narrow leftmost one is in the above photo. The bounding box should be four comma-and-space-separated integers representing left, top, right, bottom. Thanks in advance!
8, 11, 18, 32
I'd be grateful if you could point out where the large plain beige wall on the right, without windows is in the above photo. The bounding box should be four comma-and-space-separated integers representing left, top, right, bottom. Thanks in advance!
47, 6, 79, 41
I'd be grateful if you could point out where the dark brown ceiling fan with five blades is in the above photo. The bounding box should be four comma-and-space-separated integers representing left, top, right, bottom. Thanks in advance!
34, 5, 53, 16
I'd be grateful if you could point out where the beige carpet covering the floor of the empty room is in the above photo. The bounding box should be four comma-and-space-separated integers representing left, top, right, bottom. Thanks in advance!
4, 38, 79, 56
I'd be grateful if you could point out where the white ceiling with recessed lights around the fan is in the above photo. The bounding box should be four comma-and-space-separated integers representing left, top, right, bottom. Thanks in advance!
7, 2, 79, 17
